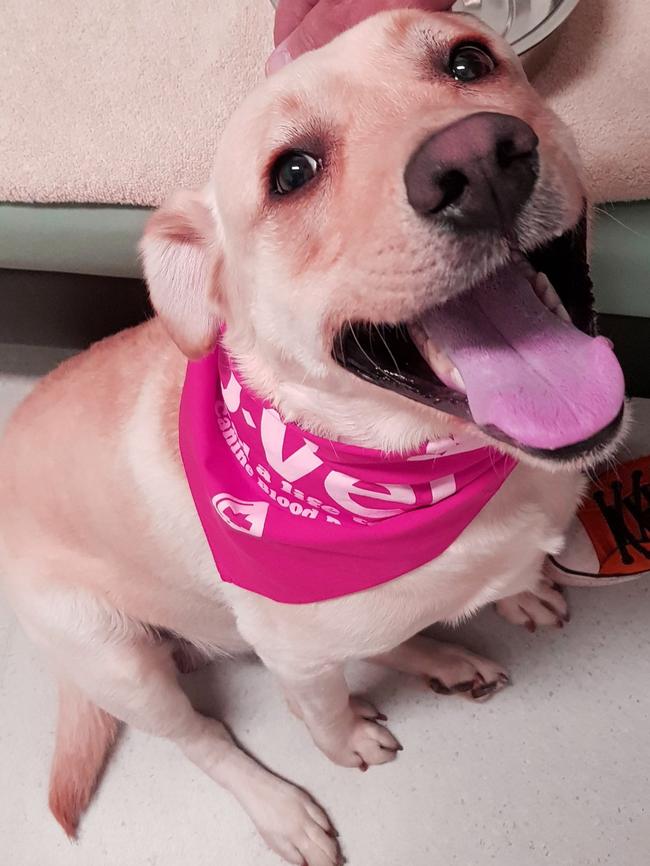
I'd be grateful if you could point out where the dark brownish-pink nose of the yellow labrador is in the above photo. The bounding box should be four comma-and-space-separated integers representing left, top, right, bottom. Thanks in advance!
404, 111, 539, 231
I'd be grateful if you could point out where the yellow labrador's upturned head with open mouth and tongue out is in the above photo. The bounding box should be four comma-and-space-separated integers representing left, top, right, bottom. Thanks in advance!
142, 11, 623, 467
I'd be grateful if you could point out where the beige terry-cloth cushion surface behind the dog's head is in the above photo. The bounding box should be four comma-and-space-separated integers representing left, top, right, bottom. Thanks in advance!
0, 0, 650, 205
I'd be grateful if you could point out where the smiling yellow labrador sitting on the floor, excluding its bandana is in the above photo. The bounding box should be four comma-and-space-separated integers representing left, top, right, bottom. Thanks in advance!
0, 11, 623, 866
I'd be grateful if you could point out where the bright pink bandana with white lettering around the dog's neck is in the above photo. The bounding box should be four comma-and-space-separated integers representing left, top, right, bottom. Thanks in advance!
179, 346, 516, 604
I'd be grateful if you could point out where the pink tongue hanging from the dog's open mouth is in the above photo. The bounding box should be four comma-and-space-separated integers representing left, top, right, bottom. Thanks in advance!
421, 265, 625, 450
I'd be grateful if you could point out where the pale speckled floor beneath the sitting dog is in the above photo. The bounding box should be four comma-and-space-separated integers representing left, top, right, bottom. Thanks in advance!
0, 350, 650, 866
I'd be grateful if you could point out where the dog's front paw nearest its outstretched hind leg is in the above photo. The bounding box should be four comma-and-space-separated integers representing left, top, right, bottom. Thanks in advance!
315, 697, 402, 771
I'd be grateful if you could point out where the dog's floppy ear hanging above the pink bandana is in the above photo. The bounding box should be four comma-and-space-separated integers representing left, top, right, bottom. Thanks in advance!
140, 191, 222, 358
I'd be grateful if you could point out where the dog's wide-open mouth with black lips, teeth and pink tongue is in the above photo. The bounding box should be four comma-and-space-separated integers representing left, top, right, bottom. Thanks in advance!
333, 220, 625, 460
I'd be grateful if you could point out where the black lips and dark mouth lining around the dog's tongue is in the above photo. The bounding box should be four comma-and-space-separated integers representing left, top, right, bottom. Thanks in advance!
332, 209, 624, 463
